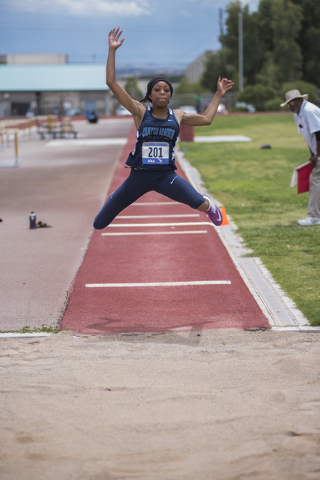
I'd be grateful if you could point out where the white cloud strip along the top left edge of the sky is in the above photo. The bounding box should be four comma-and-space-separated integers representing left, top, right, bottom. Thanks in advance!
1, 0, 151, 17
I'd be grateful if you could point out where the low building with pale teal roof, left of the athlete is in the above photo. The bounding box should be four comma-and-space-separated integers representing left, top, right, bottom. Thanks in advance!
0, 64, 113, 118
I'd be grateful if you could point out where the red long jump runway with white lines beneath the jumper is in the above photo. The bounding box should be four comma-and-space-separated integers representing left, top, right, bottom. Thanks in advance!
60, 127, 269, 334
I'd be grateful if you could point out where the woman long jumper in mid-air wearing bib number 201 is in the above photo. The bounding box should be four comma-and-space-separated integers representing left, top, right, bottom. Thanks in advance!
93, 28, 233, 229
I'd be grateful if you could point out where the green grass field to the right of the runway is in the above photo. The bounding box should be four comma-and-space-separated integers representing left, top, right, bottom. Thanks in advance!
181, 114, 320, 325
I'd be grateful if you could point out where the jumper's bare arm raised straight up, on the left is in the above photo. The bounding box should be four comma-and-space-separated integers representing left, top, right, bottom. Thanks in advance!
107, 28, 145, 126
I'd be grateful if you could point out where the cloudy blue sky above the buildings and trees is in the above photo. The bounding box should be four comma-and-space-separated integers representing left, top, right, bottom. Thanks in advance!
0, 0, 259, 67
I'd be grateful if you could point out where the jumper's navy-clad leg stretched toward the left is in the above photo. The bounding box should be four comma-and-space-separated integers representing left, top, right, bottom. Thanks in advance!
93, 170, 151, 230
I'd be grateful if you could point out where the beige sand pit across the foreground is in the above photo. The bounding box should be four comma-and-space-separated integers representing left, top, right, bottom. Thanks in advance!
0, 329, 320, 480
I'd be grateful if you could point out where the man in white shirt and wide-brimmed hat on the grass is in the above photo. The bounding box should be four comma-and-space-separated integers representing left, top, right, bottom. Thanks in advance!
281, 90, 320, 226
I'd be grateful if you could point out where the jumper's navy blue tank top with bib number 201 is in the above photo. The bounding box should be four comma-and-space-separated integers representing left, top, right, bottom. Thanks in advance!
126, 107, 180, 170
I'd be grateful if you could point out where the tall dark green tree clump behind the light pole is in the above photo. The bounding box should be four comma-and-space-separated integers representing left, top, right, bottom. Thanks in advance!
201, 0, 320, 91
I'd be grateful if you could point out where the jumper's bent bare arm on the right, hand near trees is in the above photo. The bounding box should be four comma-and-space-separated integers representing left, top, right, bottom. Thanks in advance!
174, 77, 234, 127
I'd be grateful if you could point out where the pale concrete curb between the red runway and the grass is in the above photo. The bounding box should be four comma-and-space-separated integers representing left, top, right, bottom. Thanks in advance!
177, 150, 310, 332
